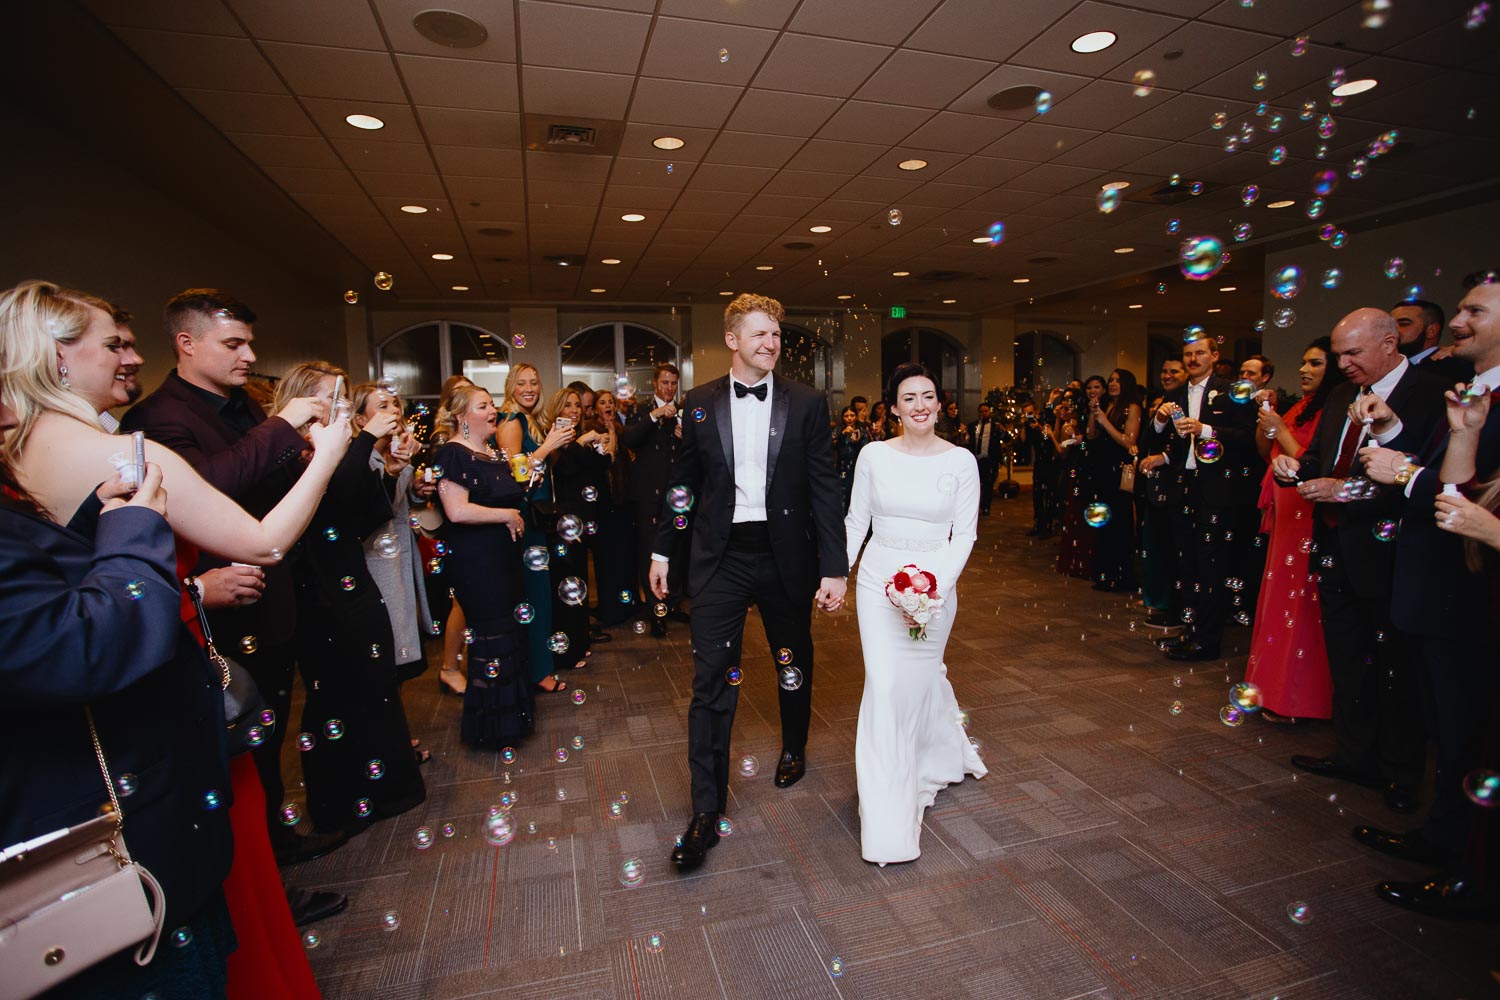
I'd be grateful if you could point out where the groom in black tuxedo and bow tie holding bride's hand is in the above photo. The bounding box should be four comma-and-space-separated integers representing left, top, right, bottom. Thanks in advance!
651, 294, 849, 871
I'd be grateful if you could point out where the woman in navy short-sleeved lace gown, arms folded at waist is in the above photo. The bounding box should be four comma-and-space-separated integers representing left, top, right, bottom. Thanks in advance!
437, 385, 536, 748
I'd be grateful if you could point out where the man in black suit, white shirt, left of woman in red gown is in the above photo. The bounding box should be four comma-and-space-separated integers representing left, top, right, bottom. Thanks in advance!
1146, 330, 1263, 660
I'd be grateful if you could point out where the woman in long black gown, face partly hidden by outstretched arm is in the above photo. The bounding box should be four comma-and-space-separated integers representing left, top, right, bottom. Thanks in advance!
276, 361, 428, 831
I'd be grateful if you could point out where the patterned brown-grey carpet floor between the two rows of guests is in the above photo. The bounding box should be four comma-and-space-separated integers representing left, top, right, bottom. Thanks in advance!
285, 496, 1500, 1000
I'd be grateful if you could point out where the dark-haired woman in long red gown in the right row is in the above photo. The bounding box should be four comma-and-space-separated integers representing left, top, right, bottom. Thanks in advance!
1245, 337, 1344, 723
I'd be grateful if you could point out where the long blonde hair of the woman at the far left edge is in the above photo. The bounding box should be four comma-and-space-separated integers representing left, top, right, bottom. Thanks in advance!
0, 280, 113, 462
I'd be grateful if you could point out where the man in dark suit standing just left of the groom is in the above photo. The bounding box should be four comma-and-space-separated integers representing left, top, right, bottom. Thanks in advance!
620, 361, 684, 639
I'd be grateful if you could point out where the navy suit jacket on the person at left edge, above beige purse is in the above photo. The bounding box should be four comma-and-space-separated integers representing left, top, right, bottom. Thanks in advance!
0, 504, 233, 930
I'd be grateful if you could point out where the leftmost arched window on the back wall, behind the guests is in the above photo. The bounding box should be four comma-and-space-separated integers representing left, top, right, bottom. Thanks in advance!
375, 319, 510, 400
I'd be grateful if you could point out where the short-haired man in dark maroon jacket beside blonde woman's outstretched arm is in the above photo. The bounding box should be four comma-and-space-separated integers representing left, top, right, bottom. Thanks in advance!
120, 288, 348, 864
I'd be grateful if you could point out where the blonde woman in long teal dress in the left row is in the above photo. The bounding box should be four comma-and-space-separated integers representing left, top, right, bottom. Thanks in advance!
501, 361, 578, 693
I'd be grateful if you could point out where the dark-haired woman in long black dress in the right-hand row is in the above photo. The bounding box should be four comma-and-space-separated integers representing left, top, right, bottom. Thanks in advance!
1085, 369, 1140, 591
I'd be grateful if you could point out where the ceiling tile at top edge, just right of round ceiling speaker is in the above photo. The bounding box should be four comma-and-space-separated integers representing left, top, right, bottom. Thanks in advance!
518, 0, 651, 73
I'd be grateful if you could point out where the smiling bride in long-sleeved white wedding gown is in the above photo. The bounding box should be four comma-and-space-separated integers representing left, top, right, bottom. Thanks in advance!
845, 364, 987, 865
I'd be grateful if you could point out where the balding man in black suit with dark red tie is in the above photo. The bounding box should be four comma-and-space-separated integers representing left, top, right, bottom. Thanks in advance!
1272, 309, 1443, 813
